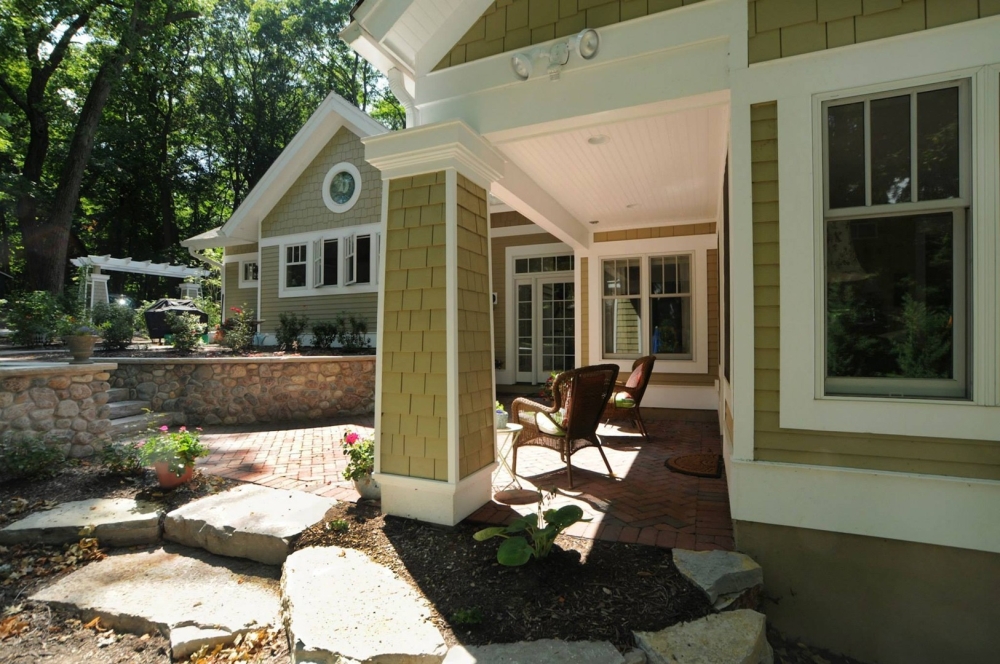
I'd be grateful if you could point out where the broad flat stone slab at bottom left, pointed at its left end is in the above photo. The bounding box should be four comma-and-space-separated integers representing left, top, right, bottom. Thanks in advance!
31, 545, 280, 659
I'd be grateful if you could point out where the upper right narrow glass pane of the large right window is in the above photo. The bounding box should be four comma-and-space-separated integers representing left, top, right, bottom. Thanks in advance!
917, 88, 960, 201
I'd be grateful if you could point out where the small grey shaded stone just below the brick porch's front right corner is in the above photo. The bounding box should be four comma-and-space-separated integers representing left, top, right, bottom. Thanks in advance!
672, 549, 764, 610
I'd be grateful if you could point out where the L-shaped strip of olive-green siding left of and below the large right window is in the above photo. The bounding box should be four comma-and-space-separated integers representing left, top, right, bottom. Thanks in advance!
751, 103, 1000, 479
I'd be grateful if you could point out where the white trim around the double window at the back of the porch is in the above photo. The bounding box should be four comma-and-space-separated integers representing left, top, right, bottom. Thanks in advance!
587, 234, 718, 374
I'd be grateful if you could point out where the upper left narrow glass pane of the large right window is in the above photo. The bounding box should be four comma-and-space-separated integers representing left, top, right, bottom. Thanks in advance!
826, 102, 865, 209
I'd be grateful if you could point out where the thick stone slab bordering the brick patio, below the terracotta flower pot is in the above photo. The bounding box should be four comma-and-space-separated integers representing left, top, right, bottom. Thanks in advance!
163, 484, 337, 565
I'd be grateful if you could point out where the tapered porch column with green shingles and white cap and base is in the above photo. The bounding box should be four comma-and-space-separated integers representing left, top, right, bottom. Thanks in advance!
363, 122, 503, 525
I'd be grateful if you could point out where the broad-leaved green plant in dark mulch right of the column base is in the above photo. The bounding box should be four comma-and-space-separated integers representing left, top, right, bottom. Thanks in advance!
473, 502, 590, 567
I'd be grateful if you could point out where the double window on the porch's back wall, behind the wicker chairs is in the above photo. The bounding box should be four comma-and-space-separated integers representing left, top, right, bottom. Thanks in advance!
602, 254, 693, 360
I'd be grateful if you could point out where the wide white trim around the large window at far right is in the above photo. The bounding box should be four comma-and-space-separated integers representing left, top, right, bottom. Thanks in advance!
778, 61, 1000, 440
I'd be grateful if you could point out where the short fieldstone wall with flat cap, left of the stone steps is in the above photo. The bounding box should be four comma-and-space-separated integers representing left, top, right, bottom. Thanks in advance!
0, 363, 117, 457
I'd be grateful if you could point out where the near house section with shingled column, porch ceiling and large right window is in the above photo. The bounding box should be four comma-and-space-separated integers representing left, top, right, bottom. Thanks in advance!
326, 0, 1000, 662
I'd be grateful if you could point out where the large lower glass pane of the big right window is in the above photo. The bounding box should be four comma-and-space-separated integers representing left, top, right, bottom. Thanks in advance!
826, 212, 956, 395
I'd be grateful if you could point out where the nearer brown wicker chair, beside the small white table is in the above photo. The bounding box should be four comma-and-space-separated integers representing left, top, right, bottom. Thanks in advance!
511, 364, 618, 489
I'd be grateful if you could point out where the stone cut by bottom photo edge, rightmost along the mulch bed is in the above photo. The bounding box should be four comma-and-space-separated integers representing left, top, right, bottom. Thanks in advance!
635, 609, 774, 664
